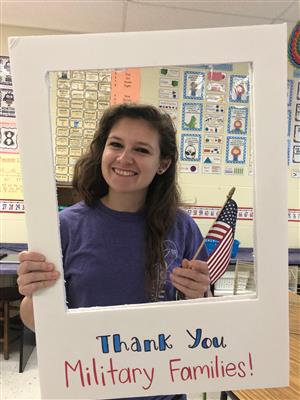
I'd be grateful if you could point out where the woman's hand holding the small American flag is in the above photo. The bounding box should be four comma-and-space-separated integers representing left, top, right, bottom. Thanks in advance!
170, 259, 210, 299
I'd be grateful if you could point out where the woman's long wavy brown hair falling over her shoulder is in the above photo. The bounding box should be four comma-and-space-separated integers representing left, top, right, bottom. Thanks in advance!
73, 104, 180, 292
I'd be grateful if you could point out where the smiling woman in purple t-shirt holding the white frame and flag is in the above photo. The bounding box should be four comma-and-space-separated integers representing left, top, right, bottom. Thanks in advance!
18, 104, 209, 329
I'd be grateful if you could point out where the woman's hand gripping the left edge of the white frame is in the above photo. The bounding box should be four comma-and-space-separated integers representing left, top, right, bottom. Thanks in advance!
17, 251, 60, 297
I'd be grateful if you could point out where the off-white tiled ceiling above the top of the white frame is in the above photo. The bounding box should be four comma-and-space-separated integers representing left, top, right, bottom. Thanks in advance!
1, 0, 299, 33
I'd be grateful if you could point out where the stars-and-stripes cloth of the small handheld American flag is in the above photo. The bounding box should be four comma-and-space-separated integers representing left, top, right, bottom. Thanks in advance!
206, 199, 238, 284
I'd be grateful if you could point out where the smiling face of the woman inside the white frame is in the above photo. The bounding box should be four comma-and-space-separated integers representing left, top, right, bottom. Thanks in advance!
101, 117, 165, 200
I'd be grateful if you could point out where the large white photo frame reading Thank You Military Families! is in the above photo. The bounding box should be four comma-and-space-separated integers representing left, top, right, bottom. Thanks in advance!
9, 24, 289, 399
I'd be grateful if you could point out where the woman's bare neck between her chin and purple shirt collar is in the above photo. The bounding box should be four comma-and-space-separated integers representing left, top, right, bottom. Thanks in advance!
101, 192, 145, 212
